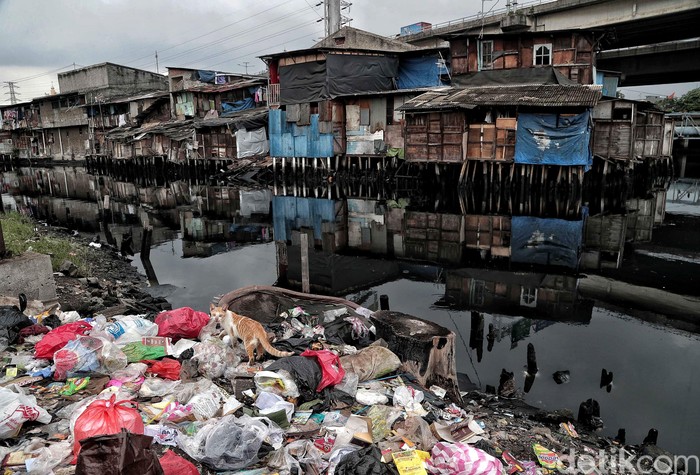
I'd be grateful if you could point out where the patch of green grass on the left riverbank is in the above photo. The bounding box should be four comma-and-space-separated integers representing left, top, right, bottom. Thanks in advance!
0, 213, 90, 276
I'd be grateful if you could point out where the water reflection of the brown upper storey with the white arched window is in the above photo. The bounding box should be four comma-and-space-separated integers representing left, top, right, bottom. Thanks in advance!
444, 268, 593, 322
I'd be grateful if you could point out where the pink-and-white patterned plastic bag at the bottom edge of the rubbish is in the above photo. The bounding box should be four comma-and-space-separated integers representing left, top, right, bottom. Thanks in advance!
426, 442, 503, 475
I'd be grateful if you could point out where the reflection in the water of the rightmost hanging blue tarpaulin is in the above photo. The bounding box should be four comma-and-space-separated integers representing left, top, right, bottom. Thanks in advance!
510, 217, 583, 269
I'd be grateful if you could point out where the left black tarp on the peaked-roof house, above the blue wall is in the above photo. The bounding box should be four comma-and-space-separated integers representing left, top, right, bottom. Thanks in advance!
279, 61, 329, 104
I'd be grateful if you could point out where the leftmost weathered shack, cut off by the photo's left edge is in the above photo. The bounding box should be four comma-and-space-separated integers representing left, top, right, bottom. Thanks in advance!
0, 102, 46, 162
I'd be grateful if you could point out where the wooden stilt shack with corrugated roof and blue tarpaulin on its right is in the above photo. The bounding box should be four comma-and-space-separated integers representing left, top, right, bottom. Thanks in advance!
400, 82, 601, 188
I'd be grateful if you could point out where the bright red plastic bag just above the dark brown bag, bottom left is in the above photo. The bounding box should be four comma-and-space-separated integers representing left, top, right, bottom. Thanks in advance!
73, 395, 144, 463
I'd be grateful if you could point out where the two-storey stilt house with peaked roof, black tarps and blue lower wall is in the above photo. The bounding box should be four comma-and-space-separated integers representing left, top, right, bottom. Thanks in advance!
263, 27, 447, 175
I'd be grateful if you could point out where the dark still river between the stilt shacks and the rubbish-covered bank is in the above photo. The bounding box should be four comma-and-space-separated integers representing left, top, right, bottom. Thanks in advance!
0, 166, 700, 462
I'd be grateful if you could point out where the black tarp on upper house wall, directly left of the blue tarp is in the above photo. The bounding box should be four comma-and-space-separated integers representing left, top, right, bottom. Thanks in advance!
326, 54, 399, 97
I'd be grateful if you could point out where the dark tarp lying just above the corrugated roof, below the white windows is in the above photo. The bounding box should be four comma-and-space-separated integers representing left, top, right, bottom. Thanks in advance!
452, 67, 577, 87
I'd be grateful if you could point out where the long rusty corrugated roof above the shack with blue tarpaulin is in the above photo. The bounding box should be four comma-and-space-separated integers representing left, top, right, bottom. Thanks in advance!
399, 84, 602, 111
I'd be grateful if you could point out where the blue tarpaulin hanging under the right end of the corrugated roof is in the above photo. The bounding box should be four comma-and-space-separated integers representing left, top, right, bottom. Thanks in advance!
515, 111, 593, 170
